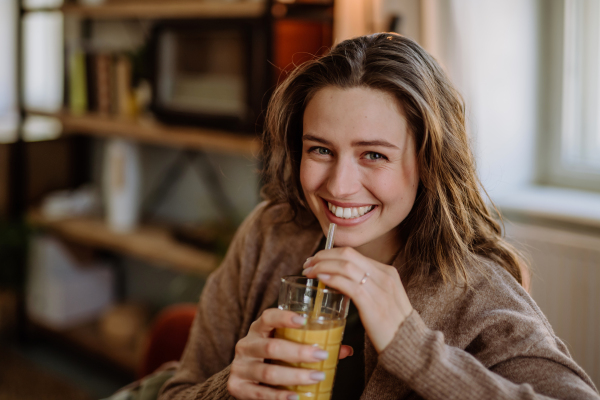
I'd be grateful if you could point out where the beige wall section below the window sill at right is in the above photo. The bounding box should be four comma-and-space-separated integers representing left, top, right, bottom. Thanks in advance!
507, 224, 600, 386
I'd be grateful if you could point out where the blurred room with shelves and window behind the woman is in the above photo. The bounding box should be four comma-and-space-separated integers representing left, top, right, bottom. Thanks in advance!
0, 0, 600, 399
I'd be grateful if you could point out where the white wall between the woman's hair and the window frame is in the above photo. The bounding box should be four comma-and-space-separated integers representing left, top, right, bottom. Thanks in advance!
426, 0, 540, 198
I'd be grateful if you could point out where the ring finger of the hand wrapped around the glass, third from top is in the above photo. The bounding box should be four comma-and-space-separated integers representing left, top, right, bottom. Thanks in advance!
238, 362, 325, 386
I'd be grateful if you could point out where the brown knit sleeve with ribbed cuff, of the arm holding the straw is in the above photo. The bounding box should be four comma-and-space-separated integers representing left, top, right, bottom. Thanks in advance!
379, 310, 600, 400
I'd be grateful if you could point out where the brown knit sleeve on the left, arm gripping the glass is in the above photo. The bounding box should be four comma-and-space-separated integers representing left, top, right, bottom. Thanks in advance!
159, 206, 262, 400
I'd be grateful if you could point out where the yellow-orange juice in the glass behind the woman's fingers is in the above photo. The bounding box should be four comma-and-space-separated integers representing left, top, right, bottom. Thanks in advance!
275, 319, 346, 400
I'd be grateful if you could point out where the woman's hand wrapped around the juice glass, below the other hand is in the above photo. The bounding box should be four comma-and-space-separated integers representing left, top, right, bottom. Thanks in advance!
227, 308, 352, 400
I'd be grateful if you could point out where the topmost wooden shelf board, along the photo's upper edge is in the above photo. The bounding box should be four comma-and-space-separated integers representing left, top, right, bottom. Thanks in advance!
62, 0, 265, 19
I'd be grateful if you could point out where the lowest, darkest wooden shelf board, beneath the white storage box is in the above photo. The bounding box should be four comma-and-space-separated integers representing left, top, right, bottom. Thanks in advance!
28, 319, 141, 377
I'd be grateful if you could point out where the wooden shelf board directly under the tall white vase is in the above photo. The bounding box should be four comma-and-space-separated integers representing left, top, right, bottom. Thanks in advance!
29, 210, 219, 276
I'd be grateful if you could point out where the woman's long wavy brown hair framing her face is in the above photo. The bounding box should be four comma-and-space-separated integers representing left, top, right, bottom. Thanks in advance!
262, 33, 527, 286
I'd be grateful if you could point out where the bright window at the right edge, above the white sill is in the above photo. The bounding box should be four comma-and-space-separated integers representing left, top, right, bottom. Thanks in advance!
546, 0, 600, 190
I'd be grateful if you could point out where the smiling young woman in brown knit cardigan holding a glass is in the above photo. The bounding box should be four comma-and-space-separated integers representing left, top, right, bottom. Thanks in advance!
161, 33, 600, 400
